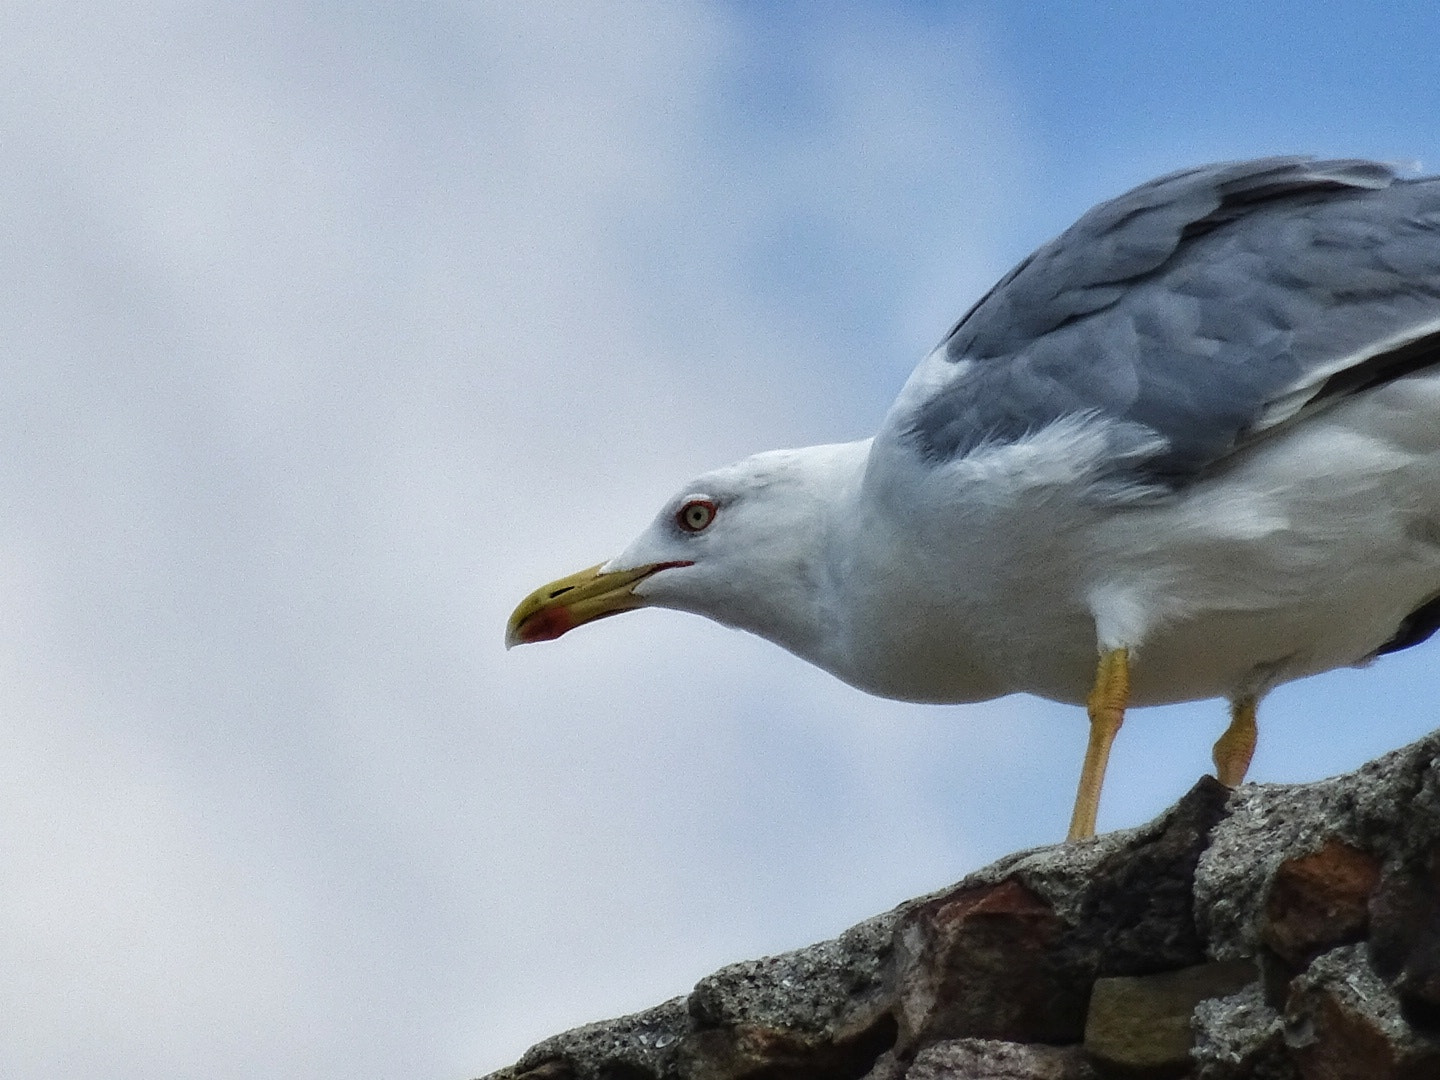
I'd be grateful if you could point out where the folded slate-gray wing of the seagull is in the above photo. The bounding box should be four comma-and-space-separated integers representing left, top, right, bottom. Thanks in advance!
881, 158, 1440, 494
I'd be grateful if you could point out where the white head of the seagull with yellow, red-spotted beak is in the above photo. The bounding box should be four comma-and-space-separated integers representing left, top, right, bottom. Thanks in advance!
505, 441, 868, 667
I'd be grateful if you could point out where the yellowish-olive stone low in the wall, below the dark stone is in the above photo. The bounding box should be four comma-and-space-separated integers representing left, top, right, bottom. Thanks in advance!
1084, 960, 1259, 1080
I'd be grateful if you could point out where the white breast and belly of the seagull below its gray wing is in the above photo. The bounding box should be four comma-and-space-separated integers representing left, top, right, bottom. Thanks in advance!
837, 376, 1440, 704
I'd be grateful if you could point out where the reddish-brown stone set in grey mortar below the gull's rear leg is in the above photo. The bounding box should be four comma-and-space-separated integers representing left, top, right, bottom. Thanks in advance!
1260, 838, 1380, 966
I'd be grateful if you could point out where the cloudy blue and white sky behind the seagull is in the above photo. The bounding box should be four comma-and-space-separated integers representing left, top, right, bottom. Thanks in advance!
8, 0, 1440, 1080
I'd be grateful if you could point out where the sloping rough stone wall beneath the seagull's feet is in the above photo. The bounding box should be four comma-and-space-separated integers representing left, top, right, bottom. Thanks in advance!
487, 733, 1440, 1080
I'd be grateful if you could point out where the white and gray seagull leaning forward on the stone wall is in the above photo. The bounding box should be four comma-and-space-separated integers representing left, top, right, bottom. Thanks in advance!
505, 157, 1440, 840
